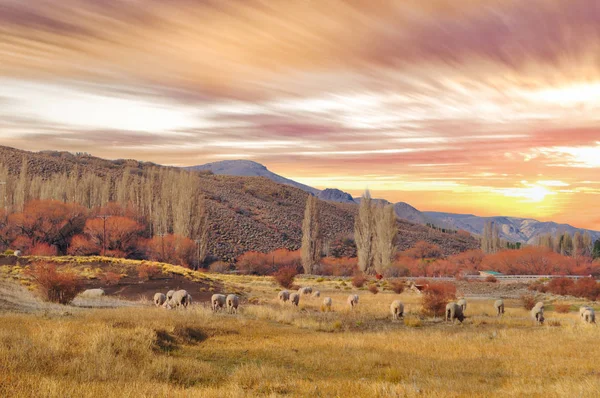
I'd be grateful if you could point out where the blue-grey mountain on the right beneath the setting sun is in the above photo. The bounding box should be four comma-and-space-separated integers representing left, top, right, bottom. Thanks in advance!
422, 211, 600, 244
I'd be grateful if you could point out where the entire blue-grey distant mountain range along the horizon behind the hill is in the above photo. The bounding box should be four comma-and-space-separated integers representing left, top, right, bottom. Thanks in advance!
188, 160, 600, 244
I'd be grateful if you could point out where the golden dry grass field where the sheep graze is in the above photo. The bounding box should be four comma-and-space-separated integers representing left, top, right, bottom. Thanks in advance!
0, 276, 600, 397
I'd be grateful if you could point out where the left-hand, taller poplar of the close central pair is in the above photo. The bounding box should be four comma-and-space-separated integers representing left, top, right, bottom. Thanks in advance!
354, 190, 375, 272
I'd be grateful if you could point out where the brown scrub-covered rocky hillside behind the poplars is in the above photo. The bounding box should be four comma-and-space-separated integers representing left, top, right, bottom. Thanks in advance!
0, 147, 478, 261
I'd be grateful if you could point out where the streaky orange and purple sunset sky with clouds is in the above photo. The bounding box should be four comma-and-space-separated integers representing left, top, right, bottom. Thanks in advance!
0, 0, 600, 230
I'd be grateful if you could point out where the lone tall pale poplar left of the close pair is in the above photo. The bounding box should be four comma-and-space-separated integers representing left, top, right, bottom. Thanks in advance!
302, 195, 323, 274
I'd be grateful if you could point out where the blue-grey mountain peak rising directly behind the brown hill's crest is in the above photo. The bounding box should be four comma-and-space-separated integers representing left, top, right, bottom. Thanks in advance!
186, 160, 320, 196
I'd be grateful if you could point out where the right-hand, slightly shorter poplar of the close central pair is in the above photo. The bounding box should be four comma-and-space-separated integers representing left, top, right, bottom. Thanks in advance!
374, 205, 398, 274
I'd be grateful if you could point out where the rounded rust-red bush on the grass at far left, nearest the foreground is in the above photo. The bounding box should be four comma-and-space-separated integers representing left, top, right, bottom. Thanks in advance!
27, 263, 83, 304
